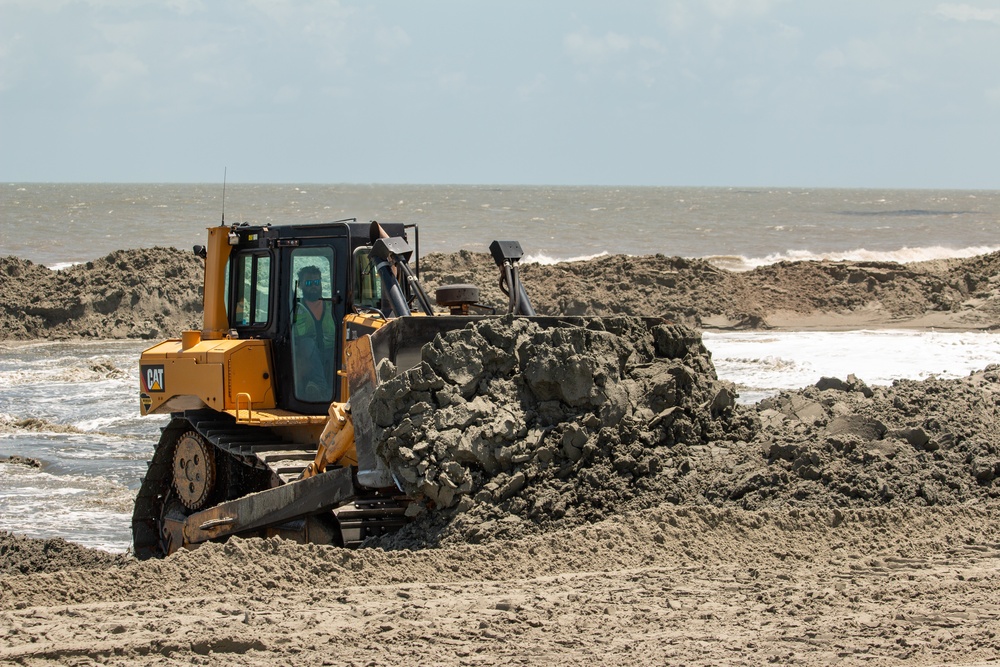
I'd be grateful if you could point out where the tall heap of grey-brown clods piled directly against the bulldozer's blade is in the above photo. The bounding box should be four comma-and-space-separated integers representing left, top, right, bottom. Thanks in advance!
369, 317, 756, 548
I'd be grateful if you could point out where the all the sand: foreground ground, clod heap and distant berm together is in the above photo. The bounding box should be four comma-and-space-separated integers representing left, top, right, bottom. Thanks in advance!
0, 249, 1000, 665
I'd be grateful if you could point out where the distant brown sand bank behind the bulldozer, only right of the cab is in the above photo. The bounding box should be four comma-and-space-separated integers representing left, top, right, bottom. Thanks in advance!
420, 251, 1000, 329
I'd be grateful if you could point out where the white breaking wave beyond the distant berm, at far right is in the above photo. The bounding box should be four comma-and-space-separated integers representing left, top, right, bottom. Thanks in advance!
702, 246, 1000, 271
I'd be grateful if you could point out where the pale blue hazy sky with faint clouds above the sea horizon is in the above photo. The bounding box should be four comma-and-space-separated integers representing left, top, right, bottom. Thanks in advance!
0, 0, 1000, 189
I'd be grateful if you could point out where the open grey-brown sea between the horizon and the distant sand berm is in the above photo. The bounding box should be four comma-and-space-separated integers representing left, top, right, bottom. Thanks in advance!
0, 183, 1000, 269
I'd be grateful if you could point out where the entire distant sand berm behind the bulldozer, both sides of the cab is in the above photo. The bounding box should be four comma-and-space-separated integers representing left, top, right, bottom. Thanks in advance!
0, 248, 1000, 339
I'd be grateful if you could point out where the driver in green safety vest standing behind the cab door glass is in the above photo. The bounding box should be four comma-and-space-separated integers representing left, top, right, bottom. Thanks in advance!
292, 266, 337, 401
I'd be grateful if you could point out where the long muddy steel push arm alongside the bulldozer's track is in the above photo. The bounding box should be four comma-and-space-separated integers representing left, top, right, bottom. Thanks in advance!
183, 468, 354, 546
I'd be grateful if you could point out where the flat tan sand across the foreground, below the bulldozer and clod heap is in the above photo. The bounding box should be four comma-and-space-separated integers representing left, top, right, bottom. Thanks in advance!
0, 506, 1000, 665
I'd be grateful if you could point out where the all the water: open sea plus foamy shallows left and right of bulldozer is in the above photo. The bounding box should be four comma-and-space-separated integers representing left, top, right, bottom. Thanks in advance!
0, 183, 1000, 552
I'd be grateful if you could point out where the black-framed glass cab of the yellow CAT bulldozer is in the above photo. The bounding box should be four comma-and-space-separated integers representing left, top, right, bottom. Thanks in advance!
225, 222, 405, 415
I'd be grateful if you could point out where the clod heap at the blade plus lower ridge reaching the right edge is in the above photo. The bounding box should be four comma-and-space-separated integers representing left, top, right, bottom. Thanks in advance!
360, 317, 1000, 548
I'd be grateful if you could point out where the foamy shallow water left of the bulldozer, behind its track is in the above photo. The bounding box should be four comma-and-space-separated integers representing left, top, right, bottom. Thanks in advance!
0, 341, 152, 551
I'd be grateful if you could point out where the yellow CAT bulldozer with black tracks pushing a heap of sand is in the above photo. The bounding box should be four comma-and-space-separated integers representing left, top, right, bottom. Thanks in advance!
132, 219, 544, 559
